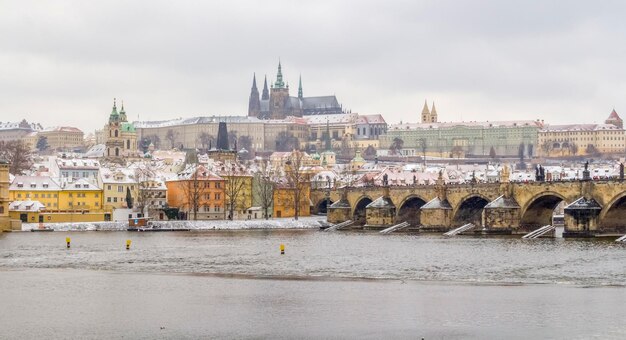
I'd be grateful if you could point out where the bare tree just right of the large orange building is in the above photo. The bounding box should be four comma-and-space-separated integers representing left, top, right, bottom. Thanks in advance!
220, 163, 252, 220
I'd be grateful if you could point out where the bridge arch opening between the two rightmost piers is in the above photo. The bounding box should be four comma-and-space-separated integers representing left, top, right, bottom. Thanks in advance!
520, 191, 567, 229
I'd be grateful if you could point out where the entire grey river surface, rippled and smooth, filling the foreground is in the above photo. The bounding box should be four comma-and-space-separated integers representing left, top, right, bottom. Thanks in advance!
0, 230, 626, 339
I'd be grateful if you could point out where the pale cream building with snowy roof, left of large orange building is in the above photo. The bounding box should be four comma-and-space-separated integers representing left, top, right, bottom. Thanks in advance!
100, 168, 139, 210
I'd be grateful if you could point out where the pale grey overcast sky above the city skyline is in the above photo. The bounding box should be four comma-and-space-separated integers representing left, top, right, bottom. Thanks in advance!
0, 0, 626, 132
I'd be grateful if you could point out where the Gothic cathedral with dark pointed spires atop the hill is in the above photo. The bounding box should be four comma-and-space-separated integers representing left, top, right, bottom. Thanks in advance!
248, 62, 343, 119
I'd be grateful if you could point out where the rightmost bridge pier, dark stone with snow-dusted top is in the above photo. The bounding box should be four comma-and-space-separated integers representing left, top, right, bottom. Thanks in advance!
563, 197, 602, 237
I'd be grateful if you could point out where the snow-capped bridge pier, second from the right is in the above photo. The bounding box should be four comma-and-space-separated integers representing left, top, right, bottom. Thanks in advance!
483, 195, 521, 234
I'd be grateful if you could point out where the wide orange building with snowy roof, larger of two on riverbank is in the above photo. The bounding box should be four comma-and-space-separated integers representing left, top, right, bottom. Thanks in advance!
165, 165, 226, 220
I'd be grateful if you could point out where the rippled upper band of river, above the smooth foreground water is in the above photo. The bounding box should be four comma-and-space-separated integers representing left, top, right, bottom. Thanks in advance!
0, 230, 626, 285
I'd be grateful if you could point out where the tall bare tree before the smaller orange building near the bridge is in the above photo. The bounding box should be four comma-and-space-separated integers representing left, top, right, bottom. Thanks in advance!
285, 150, 310, 220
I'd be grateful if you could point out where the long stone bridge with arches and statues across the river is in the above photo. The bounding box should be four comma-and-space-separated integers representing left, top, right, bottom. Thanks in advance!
311, 173, 626, 236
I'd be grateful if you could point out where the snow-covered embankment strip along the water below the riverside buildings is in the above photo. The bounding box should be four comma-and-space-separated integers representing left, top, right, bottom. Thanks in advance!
22, 216, 326, 231
